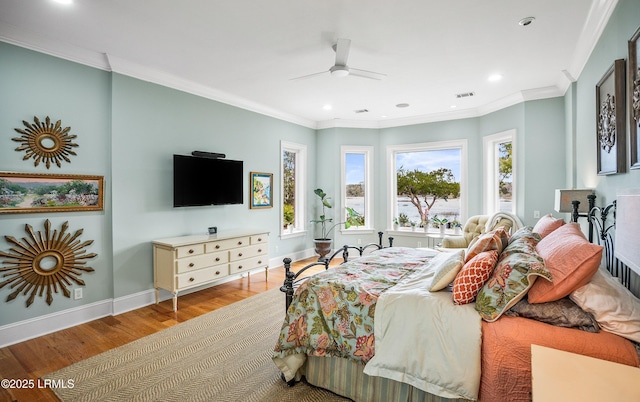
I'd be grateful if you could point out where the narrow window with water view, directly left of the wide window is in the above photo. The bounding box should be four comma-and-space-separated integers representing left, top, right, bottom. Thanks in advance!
340, 146, 373, 231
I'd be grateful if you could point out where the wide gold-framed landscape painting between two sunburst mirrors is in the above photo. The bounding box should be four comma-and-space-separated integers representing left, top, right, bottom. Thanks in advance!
0, 172, 104, 214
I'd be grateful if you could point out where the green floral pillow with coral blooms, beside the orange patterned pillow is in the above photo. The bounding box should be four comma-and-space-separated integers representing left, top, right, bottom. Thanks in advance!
476, 230, 551, 322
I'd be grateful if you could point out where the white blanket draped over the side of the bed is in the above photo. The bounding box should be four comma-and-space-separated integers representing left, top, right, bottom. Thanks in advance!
364, 253, 482, 400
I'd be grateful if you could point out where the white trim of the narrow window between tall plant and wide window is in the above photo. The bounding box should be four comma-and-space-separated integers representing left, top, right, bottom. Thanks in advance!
340, 145, 375, 233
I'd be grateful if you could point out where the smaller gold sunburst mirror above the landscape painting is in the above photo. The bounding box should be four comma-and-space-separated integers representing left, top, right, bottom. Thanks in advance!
12, 116, 78, 169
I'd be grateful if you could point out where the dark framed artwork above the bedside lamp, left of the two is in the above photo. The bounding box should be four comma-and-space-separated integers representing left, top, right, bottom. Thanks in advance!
596, 59, 627, 175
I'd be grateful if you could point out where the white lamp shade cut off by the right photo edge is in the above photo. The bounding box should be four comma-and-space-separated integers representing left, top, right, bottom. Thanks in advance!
615, 189, 640, 274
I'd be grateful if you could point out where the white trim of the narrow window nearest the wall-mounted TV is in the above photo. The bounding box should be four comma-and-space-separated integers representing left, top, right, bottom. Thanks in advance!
280, 141, 308, 238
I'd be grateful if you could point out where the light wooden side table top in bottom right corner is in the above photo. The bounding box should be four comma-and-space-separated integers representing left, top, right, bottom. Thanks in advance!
531, 345, 640, 402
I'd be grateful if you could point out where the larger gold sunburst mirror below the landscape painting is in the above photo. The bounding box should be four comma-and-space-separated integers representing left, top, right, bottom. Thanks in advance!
0, 219, 97, 307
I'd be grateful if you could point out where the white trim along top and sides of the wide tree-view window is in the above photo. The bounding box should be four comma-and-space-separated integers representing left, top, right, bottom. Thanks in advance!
387, 139, 469, 230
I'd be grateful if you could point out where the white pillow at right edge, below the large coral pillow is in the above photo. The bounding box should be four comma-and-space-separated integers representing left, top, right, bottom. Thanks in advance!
569, 269, 640, 342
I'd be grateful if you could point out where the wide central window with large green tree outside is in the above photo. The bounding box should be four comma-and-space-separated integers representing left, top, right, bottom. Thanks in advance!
387, 140, 467, 230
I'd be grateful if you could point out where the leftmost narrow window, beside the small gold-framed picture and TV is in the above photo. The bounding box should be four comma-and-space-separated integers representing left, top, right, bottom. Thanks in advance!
280, 141, 307, 235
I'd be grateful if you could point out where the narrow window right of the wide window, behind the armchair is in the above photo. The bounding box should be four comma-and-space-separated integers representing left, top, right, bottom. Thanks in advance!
484, 130, 516, 214
